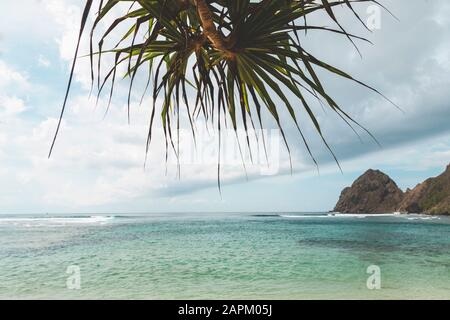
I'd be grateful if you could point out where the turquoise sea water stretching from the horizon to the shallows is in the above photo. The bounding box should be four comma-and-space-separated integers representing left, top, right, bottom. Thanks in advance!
0, 214, 450, 299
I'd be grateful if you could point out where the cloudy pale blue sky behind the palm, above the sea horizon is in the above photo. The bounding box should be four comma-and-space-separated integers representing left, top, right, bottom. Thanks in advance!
0, 0, 450, 214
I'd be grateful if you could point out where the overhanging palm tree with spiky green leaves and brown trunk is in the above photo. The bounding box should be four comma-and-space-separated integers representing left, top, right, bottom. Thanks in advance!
50, 0, 394, 182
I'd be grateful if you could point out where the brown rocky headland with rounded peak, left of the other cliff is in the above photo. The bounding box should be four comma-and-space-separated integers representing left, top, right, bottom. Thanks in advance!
334, 170, 404, 213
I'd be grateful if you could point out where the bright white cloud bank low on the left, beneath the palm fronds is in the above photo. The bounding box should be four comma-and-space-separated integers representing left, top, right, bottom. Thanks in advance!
0, 91, 270, 209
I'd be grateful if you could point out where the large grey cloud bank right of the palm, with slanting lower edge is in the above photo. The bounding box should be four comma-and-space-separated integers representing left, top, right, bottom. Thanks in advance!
264, 0, 450, 165
